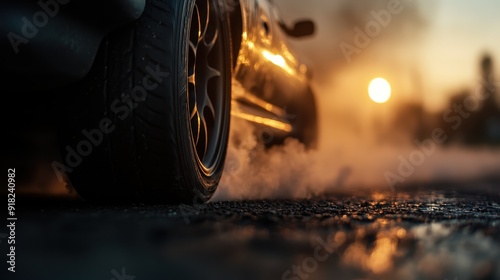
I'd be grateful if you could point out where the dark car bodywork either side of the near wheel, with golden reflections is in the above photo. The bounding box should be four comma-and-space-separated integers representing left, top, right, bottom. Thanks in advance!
0, 0, 309, 136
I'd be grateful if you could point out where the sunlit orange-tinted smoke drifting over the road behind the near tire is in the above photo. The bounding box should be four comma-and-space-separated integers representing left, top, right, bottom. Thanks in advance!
212, 81, 500, 201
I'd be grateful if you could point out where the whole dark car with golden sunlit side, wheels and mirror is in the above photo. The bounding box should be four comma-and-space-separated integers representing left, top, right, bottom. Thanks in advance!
0, 0, 317, 203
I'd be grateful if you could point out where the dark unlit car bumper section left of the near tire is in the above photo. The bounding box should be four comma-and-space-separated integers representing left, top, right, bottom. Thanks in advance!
0, 0, 145, 91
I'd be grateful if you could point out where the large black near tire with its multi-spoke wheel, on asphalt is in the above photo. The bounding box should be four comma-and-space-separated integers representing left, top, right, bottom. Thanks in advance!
60, 0, 231, 204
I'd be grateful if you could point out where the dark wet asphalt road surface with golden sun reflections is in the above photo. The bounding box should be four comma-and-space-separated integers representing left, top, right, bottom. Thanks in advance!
0, 188, 500, 280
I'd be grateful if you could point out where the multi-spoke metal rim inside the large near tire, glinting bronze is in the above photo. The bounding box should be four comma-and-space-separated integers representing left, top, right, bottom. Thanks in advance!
188, 0, 225, 175
